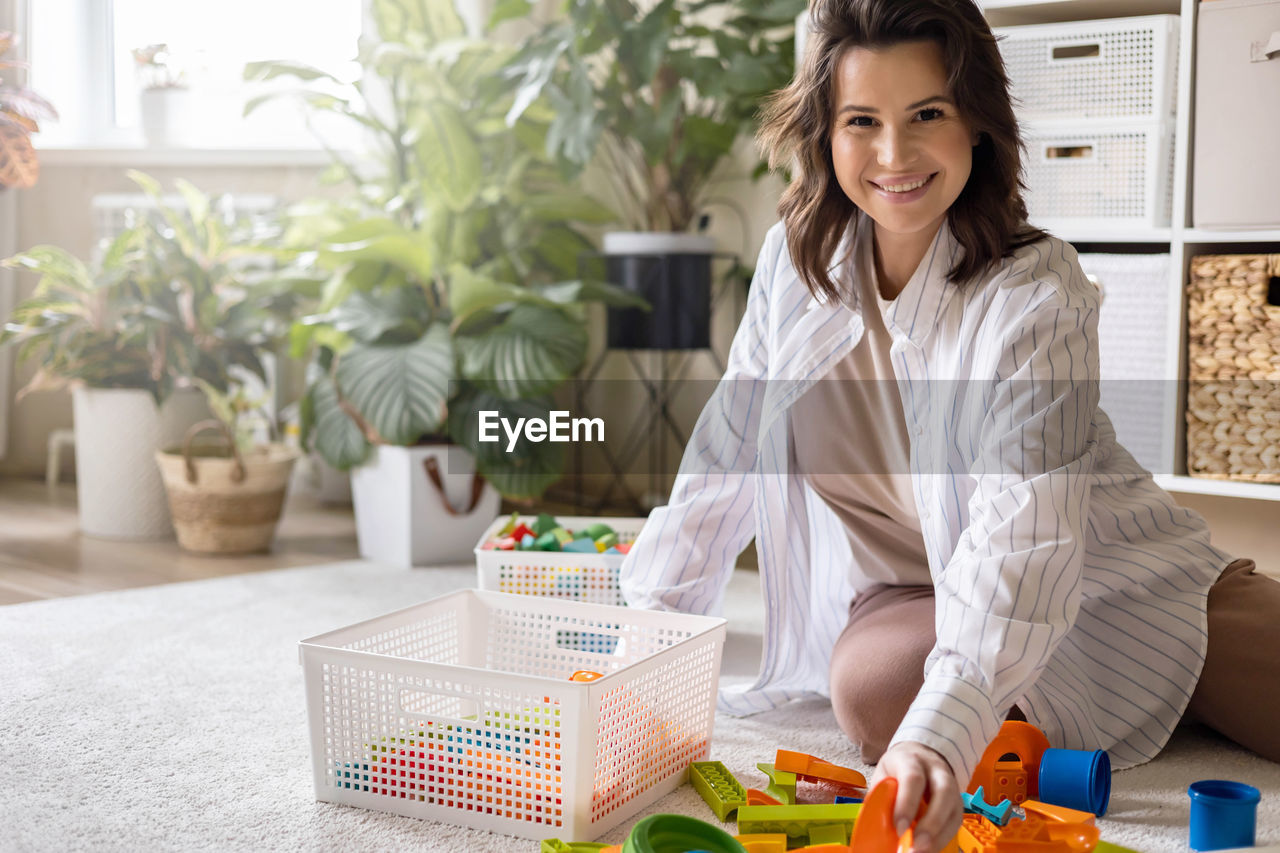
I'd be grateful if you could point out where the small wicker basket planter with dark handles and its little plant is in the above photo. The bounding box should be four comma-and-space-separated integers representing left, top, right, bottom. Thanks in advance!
155, 380, 298, 555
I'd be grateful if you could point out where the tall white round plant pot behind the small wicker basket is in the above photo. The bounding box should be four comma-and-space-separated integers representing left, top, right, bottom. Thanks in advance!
72, 388, 209, 539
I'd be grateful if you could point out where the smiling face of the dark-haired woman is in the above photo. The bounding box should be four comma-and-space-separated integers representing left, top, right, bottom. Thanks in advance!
831, 41, 978, 240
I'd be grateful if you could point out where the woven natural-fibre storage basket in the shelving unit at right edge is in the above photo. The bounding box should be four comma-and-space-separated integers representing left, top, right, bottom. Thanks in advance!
1187, 255, 1280, 483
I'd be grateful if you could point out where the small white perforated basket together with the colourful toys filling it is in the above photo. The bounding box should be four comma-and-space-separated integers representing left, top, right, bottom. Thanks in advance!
475, 514, 645, 605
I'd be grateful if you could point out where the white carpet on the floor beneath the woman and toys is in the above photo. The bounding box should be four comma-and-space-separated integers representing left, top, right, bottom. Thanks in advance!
0, 562, 1280, 853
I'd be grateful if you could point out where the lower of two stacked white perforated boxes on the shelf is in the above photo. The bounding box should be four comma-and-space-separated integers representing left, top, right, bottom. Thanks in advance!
1023, 122, 1174, 232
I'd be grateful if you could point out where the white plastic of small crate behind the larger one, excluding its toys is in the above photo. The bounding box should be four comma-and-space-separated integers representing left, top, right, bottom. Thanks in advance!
476, 515, 645, 605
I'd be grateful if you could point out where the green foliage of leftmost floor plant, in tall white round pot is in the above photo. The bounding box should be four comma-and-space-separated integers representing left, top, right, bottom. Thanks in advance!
0, 172, 298, 403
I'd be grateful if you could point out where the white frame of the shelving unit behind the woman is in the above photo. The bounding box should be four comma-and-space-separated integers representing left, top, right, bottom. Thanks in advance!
979, 0, 1280, 501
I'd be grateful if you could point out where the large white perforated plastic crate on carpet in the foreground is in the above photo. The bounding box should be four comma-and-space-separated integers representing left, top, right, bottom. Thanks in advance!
300, 589, 724, 840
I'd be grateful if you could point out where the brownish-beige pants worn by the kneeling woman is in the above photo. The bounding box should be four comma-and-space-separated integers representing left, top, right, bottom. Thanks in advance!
831, 560, 1280, 763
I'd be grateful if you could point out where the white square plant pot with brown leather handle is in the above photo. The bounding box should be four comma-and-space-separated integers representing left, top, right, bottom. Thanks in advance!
351, 444, 502, 569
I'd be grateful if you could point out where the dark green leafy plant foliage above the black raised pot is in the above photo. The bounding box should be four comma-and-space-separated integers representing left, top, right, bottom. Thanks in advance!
495, 0, 806, 232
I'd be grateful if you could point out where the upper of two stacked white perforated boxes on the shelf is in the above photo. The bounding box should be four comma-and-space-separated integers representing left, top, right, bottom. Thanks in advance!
995, 15, 1178, 122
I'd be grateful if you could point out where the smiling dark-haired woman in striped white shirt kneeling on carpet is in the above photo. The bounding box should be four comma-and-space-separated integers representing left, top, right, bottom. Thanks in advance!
622, 0, 1280, 850
